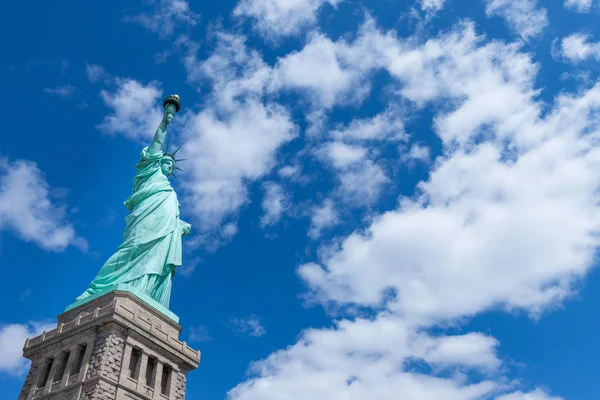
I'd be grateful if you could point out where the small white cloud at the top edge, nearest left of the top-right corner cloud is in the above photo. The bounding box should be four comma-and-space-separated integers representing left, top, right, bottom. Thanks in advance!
485, 0, 548, 40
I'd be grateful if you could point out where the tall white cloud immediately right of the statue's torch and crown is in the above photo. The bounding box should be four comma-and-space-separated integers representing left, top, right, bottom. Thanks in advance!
181, 34, 298, 239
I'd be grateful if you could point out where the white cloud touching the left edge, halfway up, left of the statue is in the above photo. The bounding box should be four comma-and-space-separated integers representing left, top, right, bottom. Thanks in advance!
0, 158, 87, 251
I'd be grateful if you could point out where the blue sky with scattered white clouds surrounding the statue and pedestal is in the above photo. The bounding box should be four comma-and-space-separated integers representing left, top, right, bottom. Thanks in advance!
0, 0, 600, 400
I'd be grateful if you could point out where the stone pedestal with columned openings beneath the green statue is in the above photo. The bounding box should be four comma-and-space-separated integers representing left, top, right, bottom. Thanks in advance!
19, 290, 200, 400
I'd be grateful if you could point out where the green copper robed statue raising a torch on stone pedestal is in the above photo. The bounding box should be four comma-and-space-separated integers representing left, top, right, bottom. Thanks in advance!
76, 95, 191, 309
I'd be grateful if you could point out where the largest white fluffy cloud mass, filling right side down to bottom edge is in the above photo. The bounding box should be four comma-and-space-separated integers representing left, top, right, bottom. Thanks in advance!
228, 19, 600, 400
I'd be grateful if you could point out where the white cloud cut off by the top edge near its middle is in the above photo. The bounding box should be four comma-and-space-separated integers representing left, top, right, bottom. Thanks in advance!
233, 0, 341, 40
